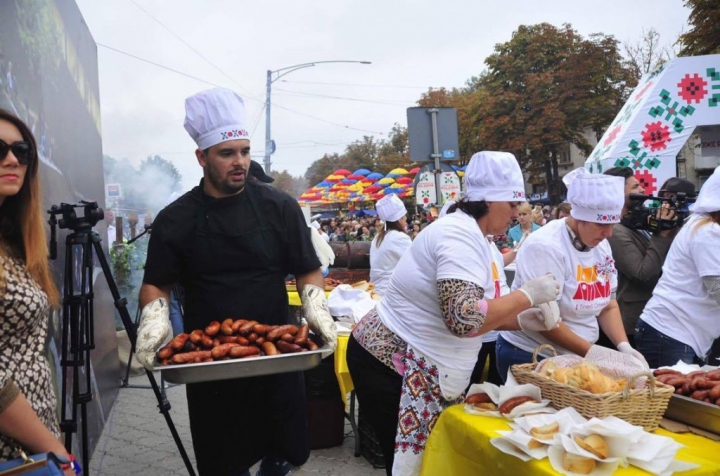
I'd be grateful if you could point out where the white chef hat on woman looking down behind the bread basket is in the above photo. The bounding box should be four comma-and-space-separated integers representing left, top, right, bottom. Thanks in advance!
563, 168, 625, 224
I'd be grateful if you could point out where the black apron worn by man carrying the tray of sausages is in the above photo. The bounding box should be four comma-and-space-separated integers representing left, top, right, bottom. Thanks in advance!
183, 183, 310, 476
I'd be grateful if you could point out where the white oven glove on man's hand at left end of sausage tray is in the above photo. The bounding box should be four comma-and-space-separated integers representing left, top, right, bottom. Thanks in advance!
135, 298, 171, 370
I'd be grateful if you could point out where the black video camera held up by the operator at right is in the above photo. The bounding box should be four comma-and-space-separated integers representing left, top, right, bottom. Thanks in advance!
620, 192, 695, 233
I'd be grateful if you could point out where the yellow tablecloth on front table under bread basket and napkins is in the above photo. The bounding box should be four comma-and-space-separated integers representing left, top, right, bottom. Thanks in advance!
422, 405, 720, 476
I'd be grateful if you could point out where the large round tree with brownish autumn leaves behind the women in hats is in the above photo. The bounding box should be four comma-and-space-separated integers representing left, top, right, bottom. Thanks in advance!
474, 23, 630, 201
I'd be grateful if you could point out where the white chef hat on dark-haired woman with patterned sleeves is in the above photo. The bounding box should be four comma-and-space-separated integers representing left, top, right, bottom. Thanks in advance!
465, 151, 525, 202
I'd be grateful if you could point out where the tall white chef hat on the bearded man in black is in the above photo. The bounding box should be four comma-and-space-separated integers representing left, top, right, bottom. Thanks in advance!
184, 88, 250, 150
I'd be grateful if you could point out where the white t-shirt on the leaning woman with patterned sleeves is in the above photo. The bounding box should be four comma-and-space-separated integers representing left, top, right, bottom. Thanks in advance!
377, 210, 499, 398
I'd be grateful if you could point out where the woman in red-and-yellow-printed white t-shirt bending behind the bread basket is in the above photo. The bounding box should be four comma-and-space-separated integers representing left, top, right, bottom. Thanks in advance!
495, 169, 647, 379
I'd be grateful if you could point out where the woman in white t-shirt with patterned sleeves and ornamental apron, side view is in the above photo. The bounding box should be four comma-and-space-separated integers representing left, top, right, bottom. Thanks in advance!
347, 152, 557, 476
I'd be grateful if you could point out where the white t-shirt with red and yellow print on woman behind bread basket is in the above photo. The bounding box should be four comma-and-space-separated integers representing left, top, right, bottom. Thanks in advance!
500, 219, 617, 356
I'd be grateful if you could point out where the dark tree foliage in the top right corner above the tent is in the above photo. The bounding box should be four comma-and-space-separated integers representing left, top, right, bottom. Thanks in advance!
678, 0, 720, 56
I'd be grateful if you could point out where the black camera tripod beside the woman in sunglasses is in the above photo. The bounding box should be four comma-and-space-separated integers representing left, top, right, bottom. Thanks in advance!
48, 202, 195, 476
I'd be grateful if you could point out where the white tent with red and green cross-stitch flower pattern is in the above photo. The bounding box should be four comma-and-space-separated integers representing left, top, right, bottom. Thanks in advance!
585, 55, 720, 195
